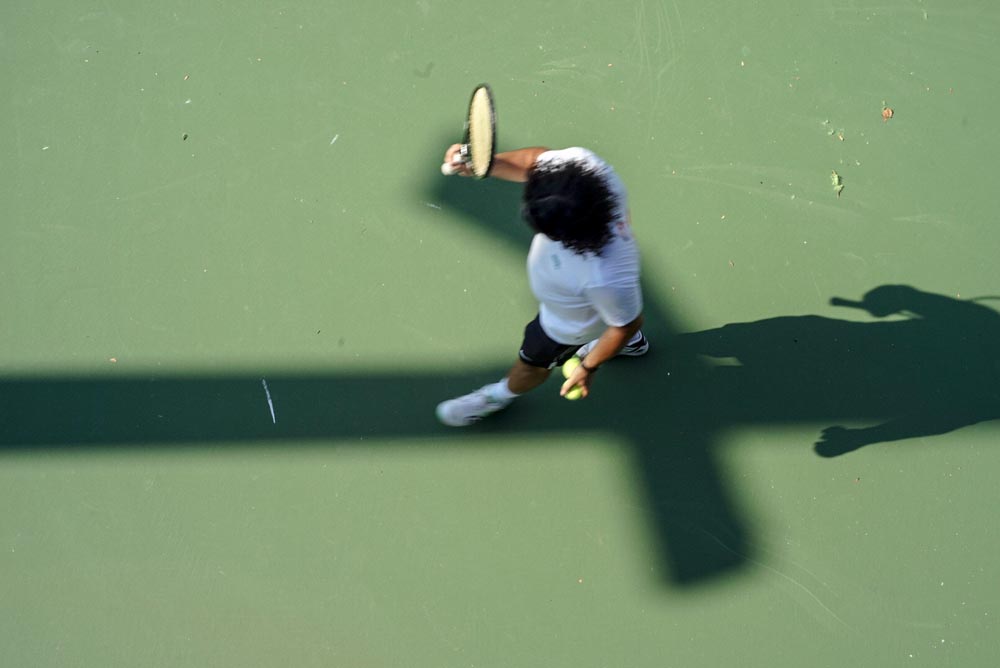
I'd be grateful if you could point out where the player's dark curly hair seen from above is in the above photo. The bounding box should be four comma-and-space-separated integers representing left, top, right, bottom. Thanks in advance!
521, 162, 615, 255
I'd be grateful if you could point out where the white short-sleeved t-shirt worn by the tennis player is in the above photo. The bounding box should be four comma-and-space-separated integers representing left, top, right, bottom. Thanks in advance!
528, 148, 642, 345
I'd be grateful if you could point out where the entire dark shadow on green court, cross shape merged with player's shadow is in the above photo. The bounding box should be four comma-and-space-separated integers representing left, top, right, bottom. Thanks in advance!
0, 175, 1000, 586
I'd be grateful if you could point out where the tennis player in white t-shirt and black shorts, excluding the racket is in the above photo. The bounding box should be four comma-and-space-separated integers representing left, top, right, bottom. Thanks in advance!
437, 144, 649, 427
